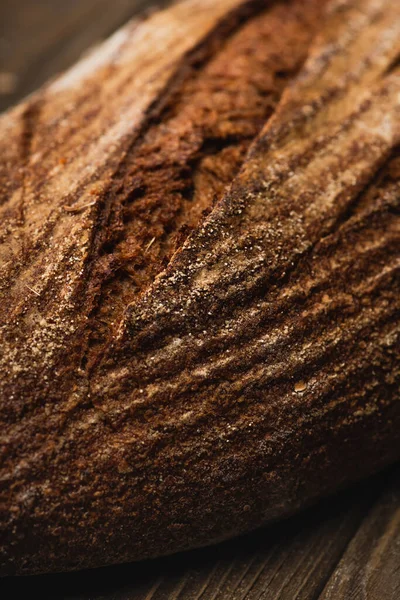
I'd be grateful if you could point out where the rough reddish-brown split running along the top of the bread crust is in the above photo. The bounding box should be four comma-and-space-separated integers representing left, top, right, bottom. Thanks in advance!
84, 2, 322, 364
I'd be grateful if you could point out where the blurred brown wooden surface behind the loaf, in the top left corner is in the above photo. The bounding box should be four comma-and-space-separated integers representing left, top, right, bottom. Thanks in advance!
0, 0, 162, 111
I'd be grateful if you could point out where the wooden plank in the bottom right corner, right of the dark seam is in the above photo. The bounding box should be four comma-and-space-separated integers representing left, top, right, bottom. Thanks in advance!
321, 470, 400, 600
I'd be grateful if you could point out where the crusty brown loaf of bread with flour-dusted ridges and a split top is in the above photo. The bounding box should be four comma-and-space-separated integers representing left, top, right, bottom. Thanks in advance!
0, 0, 400, 574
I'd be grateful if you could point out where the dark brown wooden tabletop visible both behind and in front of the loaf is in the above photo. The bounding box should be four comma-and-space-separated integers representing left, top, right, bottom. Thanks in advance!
0, 0, 400, 600
